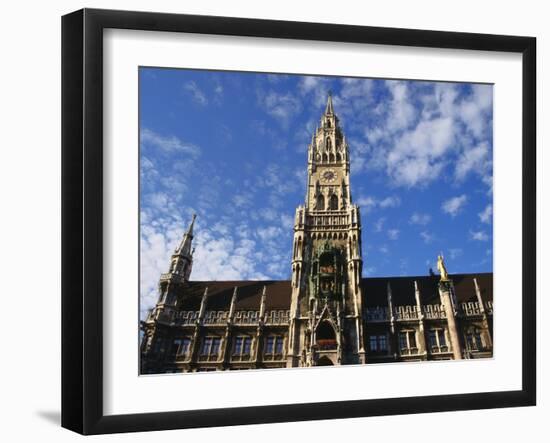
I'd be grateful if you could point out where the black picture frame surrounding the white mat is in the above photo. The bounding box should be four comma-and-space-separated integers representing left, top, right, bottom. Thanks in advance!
62, 9, 536, 434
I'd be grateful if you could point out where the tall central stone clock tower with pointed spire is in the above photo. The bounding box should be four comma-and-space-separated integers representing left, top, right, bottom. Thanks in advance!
287, 94, 365, 366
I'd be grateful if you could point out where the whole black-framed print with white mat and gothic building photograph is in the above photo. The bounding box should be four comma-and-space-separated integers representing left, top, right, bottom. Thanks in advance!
62, 9, 536, 434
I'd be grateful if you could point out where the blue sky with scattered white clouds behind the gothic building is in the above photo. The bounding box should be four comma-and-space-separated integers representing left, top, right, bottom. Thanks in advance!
139, 68, 493, 320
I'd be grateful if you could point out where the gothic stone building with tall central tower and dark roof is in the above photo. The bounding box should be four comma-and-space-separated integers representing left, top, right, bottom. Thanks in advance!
140, 96, 493, 374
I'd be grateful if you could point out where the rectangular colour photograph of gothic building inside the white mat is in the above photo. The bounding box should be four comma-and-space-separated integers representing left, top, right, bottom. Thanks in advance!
136, 69, 496, 375
